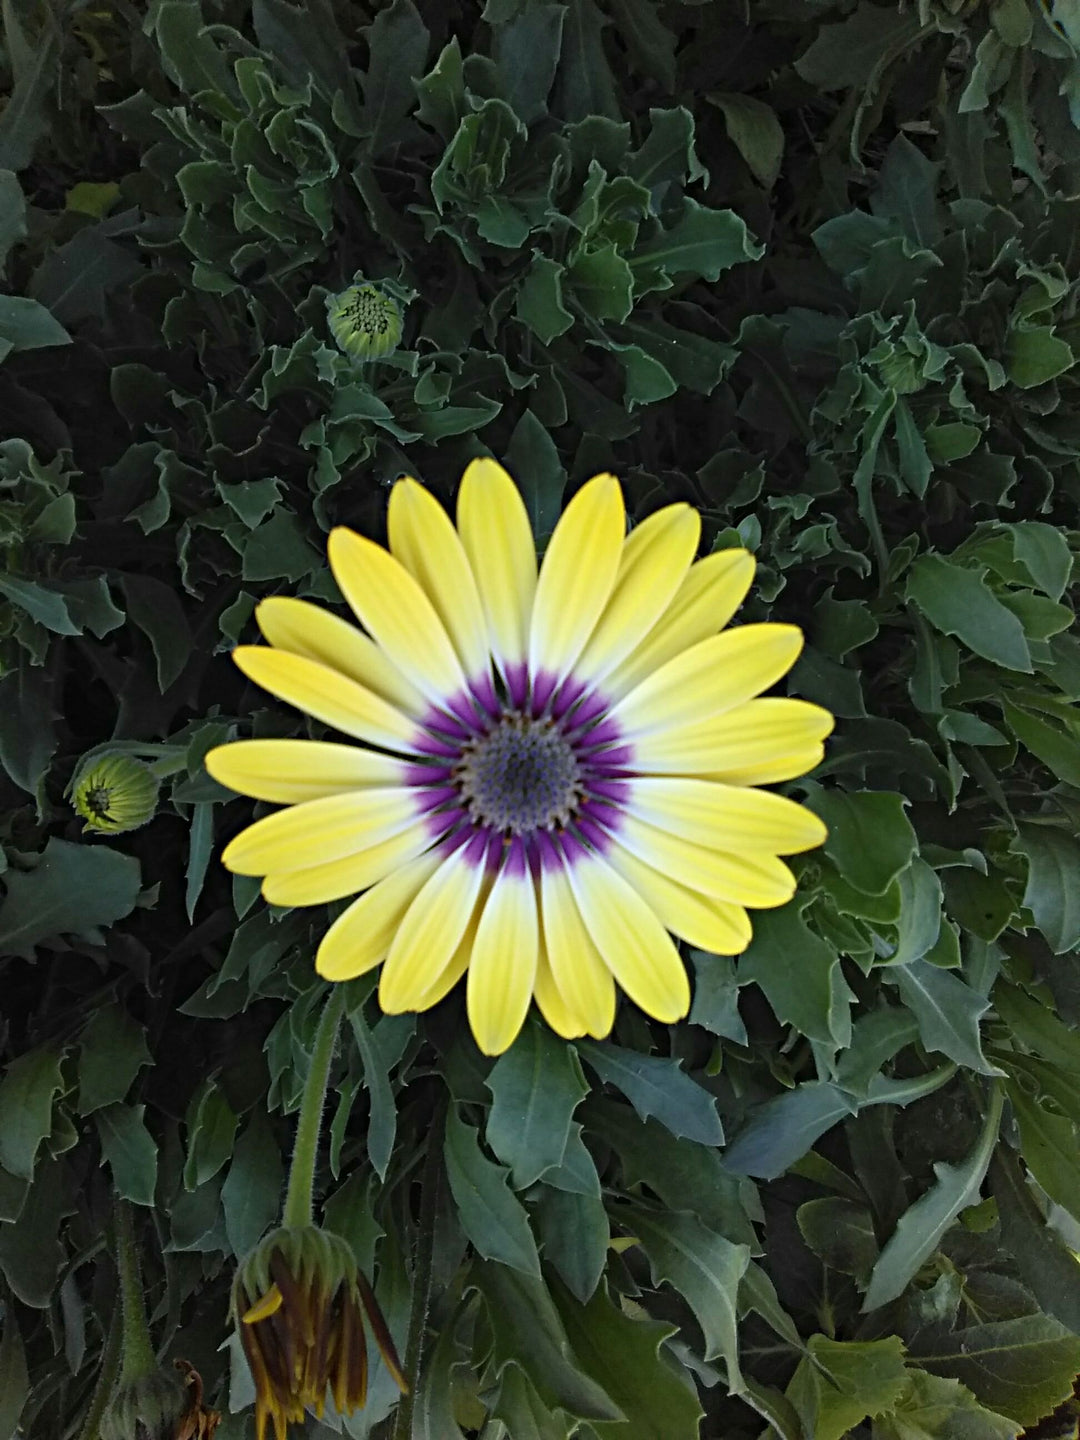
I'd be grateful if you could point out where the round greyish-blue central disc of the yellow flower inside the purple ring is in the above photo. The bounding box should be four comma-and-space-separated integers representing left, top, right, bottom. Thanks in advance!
455, 714, 582, 835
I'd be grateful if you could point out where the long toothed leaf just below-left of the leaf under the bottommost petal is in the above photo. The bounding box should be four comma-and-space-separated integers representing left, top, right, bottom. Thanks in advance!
444, 1109, 540, 1276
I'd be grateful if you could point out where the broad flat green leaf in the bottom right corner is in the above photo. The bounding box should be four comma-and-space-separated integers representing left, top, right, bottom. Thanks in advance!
912, 1315, 1080, 1440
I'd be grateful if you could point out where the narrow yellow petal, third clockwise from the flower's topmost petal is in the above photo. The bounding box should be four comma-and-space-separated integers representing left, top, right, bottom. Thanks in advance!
603, 550, 755, 697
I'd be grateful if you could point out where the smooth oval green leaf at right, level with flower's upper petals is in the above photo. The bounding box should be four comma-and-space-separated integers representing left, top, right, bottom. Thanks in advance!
906, 554, 1031, 674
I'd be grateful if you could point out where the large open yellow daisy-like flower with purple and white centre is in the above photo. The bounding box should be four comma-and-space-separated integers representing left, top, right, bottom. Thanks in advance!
206, 459, 832, 1054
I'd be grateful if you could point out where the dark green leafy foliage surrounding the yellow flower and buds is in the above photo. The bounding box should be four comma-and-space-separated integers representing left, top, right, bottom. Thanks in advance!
0, 0, 1080, 1440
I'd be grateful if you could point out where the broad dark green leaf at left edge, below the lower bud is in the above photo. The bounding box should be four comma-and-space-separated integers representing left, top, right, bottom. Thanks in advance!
0, 835, 140, 960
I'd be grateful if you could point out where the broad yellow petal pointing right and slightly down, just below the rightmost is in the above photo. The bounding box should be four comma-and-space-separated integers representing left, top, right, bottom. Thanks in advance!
626, 775, 828, 855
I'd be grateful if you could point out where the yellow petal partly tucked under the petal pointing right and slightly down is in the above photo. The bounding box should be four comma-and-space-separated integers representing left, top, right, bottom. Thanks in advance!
618, 815, 795, 910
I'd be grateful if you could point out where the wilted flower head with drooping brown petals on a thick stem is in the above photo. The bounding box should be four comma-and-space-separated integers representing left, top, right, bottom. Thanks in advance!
233, 1225, 408, 1440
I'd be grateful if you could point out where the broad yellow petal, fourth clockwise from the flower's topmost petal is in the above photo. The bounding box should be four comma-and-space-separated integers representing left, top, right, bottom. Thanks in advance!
611, 622, 802, 740
